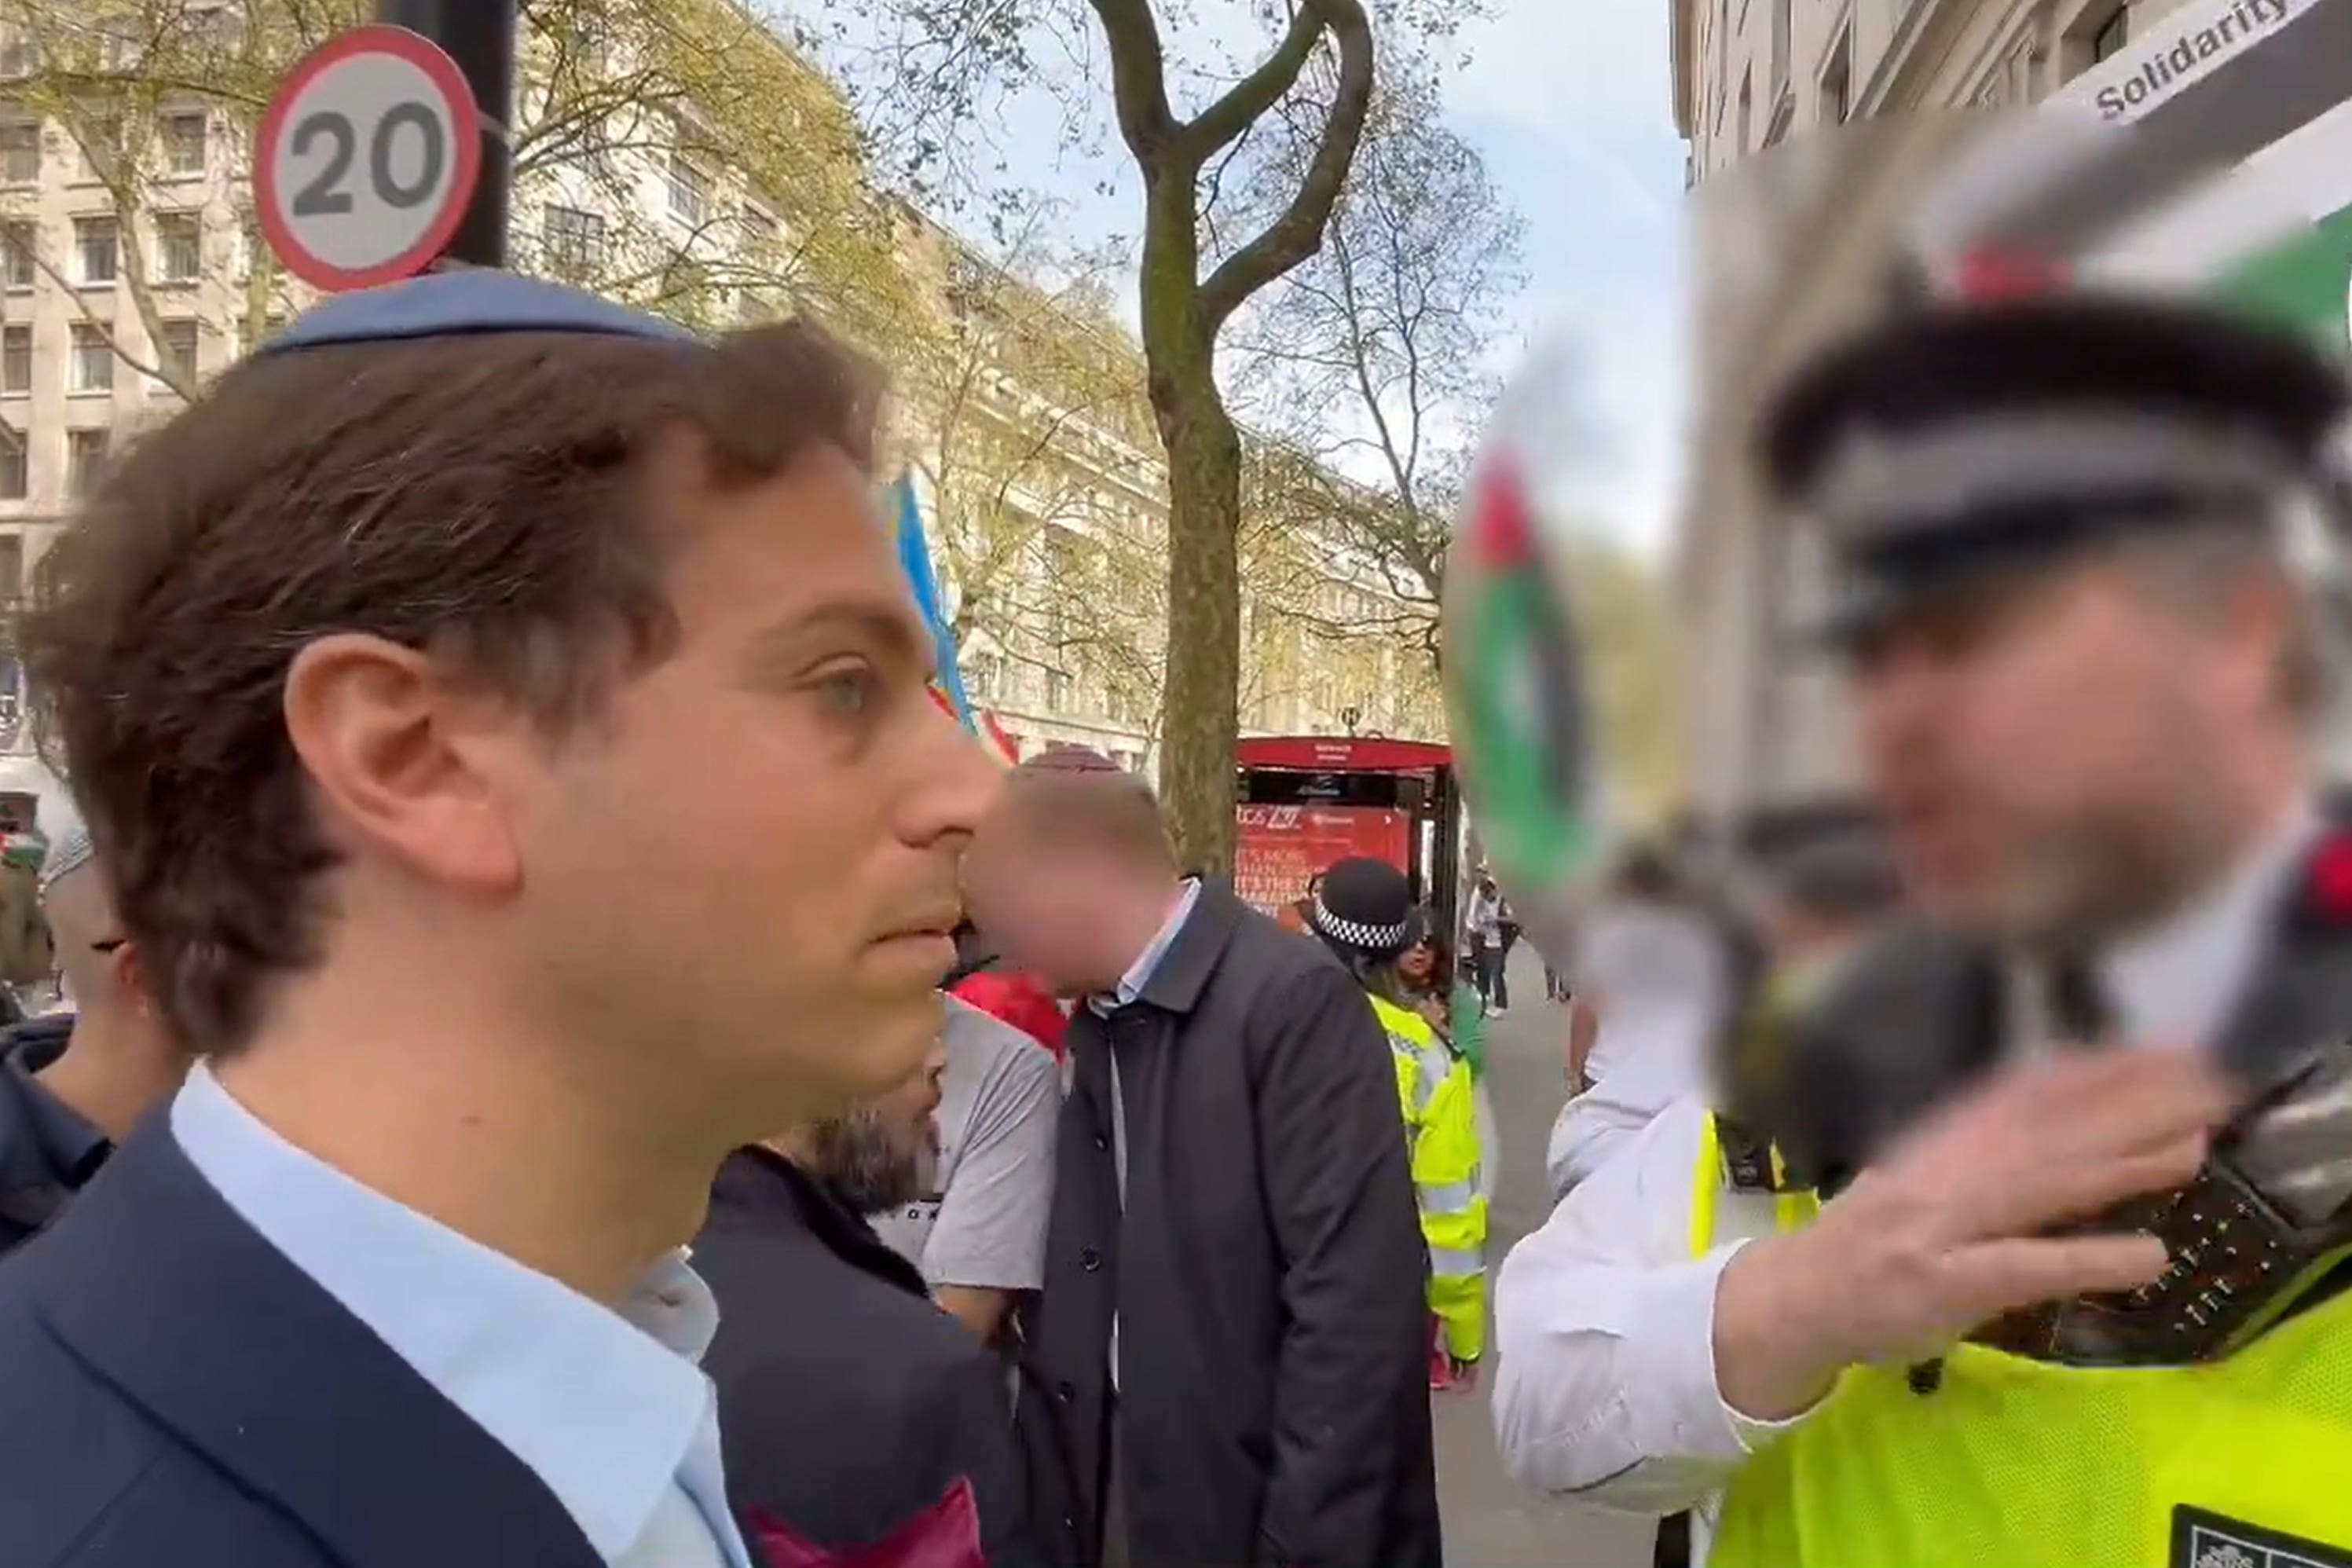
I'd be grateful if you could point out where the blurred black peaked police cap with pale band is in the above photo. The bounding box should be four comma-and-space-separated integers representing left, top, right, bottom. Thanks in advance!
1757, 291, 2352, 639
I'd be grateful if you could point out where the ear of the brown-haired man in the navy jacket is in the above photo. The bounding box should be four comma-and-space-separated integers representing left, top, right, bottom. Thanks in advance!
284, 632, 522, 896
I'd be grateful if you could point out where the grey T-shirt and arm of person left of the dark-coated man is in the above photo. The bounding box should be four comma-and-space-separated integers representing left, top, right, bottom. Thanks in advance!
875, 997, 1061, 1345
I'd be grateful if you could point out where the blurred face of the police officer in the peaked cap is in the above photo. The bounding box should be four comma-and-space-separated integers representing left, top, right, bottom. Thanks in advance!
1856, 562, 2277, 940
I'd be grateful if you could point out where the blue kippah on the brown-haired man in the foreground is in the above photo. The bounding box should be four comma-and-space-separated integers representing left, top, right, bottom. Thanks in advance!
254, 268, 701, 357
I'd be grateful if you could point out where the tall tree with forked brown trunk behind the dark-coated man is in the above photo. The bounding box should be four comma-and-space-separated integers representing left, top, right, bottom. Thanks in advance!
827, 0, 1479, 870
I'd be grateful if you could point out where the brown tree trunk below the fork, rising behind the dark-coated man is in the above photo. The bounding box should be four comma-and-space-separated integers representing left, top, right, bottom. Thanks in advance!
1155, 381, 1242, 877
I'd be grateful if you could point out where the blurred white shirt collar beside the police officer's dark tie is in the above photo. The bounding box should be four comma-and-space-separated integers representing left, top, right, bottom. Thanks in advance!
2098, 801, 2321, 1046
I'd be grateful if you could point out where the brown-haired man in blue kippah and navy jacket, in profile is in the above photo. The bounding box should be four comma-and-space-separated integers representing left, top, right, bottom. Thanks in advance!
0, 270, 997, 1568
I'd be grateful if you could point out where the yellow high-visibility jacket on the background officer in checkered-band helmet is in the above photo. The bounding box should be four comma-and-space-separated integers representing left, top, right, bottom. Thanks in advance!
1372, 997, 1486, 1361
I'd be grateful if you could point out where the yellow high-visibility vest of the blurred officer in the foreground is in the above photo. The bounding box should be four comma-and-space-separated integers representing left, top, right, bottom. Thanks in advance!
1694, 1119, 2352, 1568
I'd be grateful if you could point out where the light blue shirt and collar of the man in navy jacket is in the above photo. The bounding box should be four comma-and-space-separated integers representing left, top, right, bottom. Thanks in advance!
172, 1065, 741, 1561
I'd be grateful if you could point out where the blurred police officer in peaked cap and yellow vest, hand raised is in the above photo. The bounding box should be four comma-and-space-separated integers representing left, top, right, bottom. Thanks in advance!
1498, 296, 2352, 1568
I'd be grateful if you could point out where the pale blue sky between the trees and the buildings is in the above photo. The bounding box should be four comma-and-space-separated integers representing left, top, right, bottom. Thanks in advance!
786, 0, 1684, 559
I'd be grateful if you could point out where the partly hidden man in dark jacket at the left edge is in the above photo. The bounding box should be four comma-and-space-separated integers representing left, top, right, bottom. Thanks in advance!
0, 825, 189, 1253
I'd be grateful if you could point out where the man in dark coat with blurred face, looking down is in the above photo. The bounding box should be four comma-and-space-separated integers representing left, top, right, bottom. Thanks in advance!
965, 753, 1442, 1568
